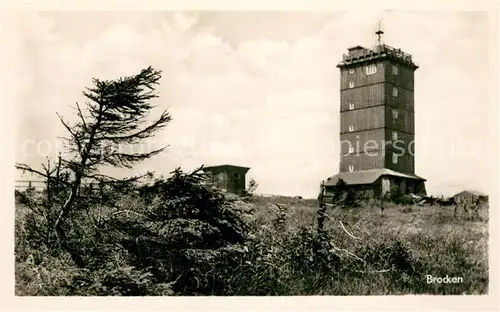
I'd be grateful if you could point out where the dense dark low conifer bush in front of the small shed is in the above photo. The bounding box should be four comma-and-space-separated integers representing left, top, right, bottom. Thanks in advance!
107, 168, 252, 295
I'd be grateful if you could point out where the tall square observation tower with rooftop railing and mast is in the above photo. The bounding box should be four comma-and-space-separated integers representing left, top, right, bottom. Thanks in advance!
325, 28, 426, 196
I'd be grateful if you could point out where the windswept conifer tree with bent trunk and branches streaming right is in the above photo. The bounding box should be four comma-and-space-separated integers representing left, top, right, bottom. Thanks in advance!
16, 67, 171, 264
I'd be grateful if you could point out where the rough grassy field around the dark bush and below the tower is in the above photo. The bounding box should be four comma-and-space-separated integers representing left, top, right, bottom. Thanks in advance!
16, 191, 488, 295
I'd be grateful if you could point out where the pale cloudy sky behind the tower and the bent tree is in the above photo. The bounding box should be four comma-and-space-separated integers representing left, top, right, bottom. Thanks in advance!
9, 11, 498, 196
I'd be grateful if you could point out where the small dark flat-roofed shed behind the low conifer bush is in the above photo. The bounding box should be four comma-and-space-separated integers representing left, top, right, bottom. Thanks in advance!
203, 165, 250, 194
